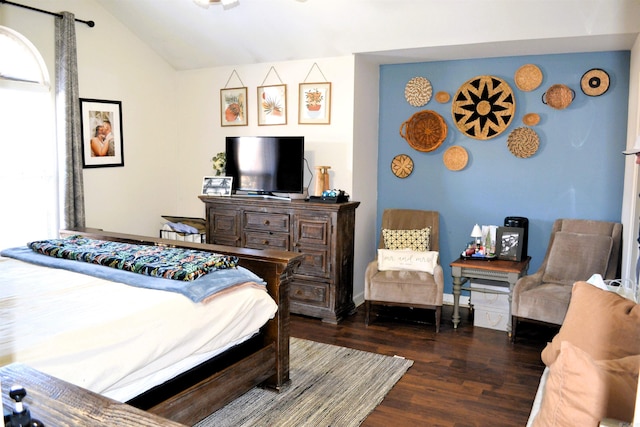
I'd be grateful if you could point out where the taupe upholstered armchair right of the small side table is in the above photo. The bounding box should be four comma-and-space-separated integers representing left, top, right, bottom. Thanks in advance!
511, 219, 622, 339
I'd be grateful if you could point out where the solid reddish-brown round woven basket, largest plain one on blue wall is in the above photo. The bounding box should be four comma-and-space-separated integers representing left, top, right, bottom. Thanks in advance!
400, 110, 447, 152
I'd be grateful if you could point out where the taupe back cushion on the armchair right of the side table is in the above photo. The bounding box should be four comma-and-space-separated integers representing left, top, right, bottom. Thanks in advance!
542, 231, 613, 285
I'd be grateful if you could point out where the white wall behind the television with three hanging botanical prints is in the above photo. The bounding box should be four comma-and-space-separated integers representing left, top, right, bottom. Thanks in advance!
176, 56, 357, 217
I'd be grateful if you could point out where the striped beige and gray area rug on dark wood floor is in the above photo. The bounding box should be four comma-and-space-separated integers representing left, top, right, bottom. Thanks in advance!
196, 338, 413, 427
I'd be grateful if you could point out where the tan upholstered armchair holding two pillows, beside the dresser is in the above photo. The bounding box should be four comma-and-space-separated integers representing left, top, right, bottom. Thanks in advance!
364, 209, 444, 332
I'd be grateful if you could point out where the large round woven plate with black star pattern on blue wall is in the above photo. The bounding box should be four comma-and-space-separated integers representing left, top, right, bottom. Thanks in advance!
451, 76, 516, 140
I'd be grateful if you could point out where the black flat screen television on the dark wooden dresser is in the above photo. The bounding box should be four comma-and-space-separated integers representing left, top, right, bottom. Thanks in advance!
225, 136, 304, 196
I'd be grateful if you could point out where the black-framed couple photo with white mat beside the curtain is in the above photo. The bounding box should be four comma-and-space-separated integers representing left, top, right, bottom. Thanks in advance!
80, 98, 124, 168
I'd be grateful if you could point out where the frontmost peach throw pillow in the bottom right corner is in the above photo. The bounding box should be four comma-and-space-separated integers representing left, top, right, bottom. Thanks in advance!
533, 341, 640, 427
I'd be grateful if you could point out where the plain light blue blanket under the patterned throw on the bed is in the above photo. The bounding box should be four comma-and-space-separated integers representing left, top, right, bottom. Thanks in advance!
0, 246, 266, 303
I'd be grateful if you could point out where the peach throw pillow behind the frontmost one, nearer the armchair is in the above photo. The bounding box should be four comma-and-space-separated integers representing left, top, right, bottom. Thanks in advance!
541, 282, 640, 366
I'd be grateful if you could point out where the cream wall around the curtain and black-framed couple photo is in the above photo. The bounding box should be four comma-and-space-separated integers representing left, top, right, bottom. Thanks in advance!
0, 0, 179, 235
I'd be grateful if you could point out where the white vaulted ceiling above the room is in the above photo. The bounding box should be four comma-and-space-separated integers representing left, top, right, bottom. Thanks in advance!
96, 0, 640, 70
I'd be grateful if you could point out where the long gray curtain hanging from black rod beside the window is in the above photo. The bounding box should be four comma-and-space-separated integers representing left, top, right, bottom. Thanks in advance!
55, 12, 85, 228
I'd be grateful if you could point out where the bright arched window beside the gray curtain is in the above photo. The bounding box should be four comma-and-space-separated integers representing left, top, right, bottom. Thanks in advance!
0, 26, 59, 249
